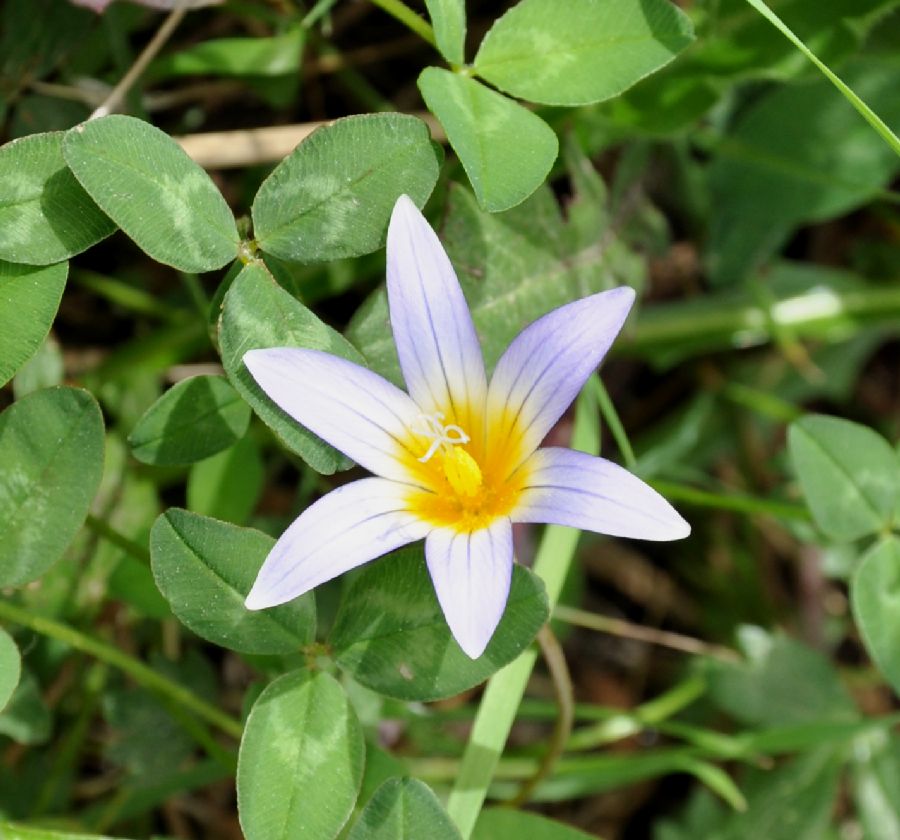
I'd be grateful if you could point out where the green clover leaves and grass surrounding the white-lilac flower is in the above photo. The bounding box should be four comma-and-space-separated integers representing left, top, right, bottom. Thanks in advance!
0, 0, 900, 840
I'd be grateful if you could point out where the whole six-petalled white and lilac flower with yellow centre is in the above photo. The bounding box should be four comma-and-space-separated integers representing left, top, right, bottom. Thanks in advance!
244, 196, 690, 659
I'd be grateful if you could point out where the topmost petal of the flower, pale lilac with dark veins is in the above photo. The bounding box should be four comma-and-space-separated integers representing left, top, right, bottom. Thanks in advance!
387, 195, 487, 426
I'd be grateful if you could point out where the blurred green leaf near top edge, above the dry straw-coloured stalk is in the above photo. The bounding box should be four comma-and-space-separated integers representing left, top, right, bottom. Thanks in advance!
150, 26, 306, 78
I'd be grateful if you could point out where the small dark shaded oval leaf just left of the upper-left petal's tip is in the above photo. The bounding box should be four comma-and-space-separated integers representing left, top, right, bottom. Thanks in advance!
128, 376, 250, 465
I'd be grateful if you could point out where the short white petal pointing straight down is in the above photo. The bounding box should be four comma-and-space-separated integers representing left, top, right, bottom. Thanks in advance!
425, 517, 513, 659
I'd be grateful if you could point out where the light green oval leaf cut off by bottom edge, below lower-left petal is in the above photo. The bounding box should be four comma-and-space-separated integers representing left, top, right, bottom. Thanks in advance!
237, 672, 365, 840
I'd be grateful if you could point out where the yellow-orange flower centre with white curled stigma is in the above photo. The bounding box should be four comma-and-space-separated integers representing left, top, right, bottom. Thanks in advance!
402, 412, 527, 531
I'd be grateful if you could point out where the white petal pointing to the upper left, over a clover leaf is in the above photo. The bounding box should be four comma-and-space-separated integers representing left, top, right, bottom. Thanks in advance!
244, 347, 420, 481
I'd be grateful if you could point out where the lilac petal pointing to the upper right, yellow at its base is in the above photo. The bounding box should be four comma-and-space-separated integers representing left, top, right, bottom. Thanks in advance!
488, 286, 634, 472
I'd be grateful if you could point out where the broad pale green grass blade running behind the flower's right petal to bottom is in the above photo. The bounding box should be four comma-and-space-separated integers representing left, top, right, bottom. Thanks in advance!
447, 385, 598, 840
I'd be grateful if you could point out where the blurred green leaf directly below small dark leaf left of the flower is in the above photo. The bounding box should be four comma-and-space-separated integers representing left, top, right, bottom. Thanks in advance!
187, 436, 265, 525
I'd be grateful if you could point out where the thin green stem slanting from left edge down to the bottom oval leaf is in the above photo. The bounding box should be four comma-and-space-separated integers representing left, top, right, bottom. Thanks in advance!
0, 600, 244, 740
